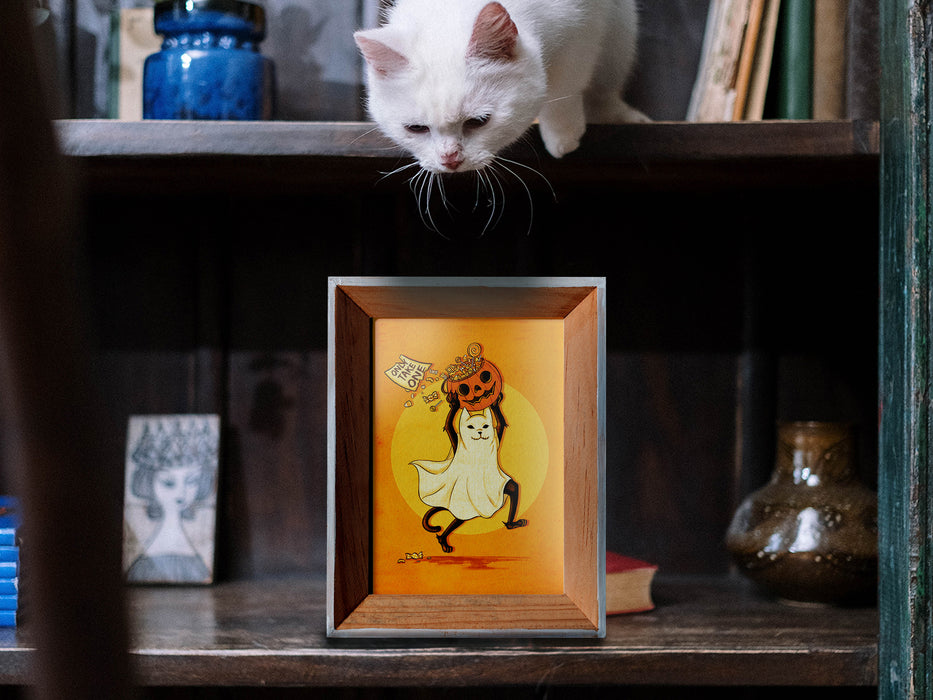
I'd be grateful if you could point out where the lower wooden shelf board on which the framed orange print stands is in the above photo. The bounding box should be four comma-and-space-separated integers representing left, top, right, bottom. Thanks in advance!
0, 578, 878, 687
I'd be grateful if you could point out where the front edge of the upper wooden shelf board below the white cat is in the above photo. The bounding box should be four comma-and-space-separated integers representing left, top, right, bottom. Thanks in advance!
57, 119, 879, 161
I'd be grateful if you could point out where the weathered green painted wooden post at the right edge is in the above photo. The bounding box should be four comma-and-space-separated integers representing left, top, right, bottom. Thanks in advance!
878, 0, 933, 698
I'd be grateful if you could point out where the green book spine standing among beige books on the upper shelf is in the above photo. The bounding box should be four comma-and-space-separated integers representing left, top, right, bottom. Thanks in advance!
777, 0, 813, 119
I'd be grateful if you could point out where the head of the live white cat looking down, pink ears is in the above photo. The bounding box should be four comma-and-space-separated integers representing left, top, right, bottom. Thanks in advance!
354, 0, 546, 173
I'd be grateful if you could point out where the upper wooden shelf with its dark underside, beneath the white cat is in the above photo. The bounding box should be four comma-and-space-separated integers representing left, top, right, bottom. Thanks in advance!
57, 120, 879, 192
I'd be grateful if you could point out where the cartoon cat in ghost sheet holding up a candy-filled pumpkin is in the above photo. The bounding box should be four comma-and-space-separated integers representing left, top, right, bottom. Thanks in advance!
411, 344, 528, 552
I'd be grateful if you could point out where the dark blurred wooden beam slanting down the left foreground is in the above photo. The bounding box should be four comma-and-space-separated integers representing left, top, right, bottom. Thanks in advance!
0, 0, 129, 698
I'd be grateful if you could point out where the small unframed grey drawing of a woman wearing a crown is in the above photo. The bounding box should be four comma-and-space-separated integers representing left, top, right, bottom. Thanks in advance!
123, 415, 220, 584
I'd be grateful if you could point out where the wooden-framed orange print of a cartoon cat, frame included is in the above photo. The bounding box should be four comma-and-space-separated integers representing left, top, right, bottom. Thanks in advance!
327, 278, 605, 637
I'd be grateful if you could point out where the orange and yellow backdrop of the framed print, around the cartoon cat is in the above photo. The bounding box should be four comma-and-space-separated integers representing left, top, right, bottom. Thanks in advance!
373, 319, 564, 594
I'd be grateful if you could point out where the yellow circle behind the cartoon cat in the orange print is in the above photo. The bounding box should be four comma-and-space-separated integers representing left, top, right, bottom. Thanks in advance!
392, 384, 549, 535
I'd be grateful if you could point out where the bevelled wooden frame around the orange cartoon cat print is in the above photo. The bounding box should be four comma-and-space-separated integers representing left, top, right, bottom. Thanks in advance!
327, 277, 606, 637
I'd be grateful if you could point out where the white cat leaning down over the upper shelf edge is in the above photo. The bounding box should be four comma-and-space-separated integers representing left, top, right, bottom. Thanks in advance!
354, 0, 647, 173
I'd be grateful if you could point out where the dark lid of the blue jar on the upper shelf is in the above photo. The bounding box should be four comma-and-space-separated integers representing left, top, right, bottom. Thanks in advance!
153, 0, 266, 39
